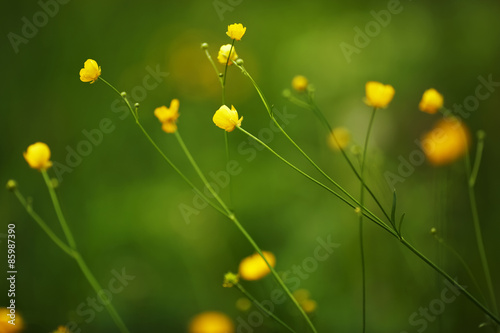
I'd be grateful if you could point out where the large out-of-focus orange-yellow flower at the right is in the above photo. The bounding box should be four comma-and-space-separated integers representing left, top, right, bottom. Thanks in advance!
422, 117, 470, 166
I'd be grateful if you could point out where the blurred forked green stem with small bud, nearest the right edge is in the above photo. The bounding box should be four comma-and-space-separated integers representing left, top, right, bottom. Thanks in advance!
465, 132, 498, 313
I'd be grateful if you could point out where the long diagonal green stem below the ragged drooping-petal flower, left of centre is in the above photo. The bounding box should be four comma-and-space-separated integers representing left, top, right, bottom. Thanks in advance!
175, 131, 317, 333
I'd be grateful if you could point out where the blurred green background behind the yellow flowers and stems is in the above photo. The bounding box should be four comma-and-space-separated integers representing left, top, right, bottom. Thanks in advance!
0, 0, 500, 332
